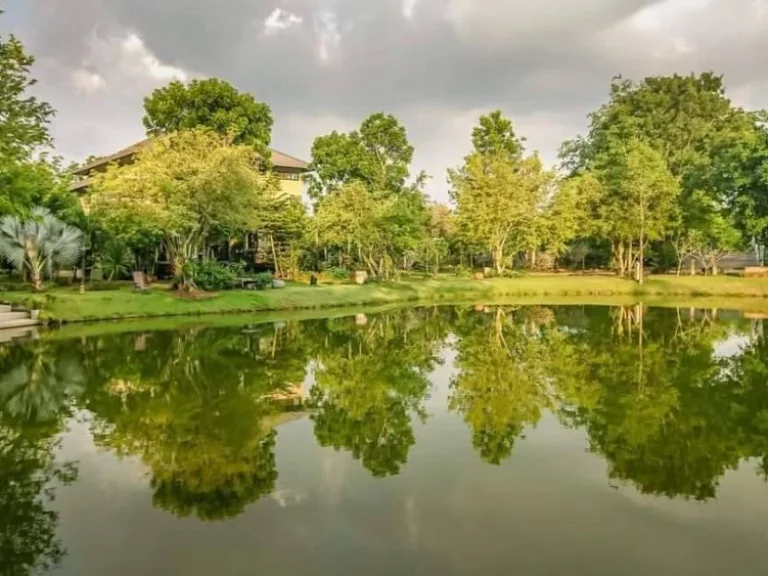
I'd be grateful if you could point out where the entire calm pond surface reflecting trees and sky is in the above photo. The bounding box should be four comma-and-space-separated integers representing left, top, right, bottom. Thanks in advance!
0, 307, 768, 576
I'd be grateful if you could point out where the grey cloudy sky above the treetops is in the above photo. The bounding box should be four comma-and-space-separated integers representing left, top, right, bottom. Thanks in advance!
0, 0, 768, 199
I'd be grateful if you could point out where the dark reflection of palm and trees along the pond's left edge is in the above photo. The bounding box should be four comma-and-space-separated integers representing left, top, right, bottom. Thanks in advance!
0, 341, 82, 576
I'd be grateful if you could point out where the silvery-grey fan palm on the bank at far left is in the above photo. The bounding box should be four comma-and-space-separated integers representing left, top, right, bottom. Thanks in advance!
0, 208, 83, 290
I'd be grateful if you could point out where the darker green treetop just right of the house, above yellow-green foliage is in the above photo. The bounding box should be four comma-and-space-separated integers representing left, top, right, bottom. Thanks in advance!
307, 113, 416, 200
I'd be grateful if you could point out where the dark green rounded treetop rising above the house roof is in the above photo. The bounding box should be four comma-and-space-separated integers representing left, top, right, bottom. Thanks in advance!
144, 78, 272, 158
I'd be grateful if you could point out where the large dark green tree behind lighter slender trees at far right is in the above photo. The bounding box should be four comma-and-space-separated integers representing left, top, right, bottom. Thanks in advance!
561, 72, 766, 269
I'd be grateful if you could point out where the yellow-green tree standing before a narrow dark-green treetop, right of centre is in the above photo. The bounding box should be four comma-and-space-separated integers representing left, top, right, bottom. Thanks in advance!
448, 153, 554, 273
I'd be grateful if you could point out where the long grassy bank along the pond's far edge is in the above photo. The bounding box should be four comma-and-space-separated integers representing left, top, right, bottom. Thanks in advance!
0, 275, 768, 322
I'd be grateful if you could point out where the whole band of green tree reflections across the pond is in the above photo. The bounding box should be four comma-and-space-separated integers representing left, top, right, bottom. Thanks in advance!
0, 306, 768, 574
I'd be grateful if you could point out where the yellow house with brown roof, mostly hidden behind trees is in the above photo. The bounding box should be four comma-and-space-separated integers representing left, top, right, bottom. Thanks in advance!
70, 138, 307, 198
